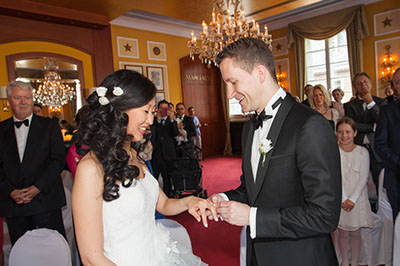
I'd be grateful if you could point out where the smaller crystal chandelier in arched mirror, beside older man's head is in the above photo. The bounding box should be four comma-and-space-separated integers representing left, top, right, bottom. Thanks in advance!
33, 59, 75, 108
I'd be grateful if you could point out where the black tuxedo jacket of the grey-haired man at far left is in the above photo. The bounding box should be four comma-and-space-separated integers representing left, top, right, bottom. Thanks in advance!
0, 115, 65, 217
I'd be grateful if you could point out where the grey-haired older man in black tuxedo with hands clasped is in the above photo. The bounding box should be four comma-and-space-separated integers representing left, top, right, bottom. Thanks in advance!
0, 81, 65, 244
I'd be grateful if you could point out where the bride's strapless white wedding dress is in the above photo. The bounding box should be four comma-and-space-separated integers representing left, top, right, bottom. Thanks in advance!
103, 169, 206, 266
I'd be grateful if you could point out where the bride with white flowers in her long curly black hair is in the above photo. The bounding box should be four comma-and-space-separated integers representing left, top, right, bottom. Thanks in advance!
72, 70, 217, 265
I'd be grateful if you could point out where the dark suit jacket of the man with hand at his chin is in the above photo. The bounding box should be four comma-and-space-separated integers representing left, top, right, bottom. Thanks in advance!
344, 96, 386, 150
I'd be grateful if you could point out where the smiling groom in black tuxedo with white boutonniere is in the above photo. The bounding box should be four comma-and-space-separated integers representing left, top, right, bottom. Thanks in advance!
209, 38, 342, 266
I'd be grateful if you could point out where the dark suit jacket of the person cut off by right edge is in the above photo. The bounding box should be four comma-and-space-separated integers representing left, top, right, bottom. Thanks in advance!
375, 100, 400, 192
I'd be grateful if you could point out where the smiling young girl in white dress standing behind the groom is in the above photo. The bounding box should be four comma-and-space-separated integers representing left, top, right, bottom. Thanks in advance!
336, 117, 372, 266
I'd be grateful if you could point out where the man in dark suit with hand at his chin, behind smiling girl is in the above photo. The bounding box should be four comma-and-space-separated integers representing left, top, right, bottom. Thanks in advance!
344, 72, 386, 189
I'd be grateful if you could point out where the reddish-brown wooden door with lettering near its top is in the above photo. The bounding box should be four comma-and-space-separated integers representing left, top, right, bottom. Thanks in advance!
180, 56, 226, 157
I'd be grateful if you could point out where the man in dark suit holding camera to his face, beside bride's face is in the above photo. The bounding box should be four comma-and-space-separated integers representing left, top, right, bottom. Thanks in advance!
151, 100, 179, 197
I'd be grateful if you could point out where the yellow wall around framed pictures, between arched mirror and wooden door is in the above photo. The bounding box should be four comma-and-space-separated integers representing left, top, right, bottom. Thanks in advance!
111, 25, 190, 104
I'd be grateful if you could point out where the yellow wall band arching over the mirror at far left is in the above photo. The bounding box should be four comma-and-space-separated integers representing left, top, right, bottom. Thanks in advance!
0, 41, 94, 121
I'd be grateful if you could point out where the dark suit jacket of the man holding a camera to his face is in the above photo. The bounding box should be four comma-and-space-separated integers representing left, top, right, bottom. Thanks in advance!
152, 117, 179, 161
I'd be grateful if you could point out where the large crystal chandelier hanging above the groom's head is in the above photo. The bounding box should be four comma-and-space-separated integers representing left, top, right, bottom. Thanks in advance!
188, 0, 272, 68
